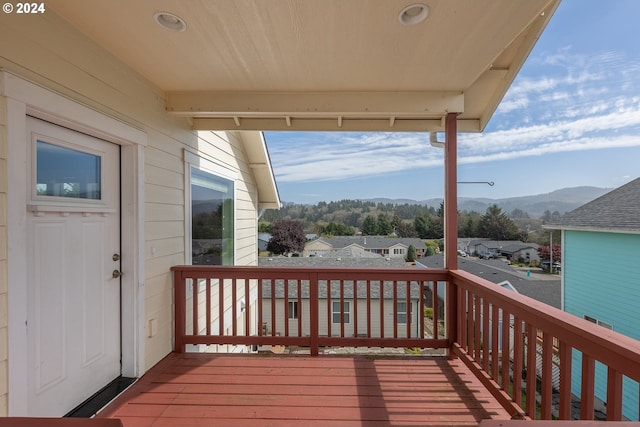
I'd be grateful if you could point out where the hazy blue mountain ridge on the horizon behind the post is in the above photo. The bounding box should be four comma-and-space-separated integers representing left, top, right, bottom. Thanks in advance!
367, 186, 612, 218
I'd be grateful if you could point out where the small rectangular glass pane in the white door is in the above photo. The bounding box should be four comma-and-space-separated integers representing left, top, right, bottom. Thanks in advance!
36, 141, 101, 200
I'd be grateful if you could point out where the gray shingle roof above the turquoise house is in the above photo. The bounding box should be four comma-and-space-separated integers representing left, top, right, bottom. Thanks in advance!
545, 178, 640, 234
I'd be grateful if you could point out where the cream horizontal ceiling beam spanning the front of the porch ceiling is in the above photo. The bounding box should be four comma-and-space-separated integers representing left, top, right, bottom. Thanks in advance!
166, 91, 464, 118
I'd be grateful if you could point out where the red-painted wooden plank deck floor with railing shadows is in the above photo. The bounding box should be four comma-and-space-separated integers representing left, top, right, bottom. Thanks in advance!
98, 353, 509, 427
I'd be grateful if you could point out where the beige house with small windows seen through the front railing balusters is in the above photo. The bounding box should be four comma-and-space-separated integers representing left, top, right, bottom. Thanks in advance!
262, 280, 420, 338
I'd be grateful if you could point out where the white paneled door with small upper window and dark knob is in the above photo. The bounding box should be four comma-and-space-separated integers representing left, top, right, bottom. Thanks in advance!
26, 118, 121, 416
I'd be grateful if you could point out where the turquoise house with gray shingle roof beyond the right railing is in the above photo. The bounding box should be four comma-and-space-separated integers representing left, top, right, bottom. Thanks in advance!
544, 178, 640, 419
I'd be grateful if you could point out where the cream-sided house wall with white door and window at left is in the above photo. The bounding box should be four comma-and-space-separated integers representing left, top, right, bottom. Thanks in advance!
0, 28, 280, 417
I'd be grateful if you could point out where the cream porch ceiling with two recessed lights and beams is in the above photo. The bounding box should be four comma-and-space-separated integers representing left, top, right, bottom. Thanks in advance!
47, 0, 560, 132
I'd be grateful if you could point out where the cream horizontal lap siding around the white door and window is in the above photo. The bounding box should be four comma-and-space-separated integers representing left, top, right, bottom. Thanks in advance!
0, 10, 257, 378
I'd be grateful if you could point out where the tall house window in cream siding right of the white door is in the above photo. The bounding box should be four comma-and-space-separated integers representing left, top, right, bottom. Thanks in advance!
189, 165, 234, 265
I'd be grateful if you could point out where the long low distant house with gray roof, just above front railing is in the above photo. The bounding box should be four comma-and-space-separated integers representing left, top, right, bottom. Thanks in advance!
303, 236, 427, 258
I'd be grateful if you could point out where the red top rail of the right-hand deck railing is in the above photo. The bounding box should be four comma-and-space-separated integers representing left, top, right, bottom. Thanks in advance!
449, 270, 640, 381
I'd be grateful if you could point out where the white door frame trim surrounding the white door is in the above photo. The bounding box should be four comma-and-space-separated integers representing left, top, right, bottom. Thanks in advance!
0, 71, 147, 416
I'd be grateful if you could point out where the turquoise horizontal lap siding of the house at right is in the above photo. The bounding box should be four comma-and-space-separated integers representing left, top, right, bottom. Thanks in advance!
563, 231, 640, 418
